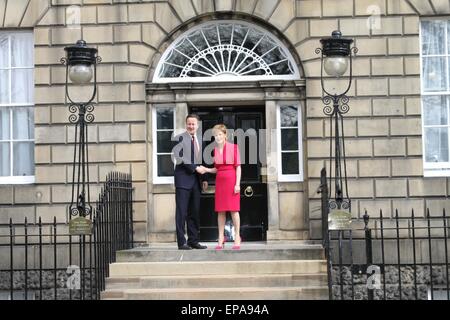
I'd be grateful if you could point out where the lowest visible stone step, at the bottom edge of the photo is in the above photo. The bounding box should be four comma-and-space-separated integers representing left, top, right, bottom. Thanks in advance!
101, 286, 328, 300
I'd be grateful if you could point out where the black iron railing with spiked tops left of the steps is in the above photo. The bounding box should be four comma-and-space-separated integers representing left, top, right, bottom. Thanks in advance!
0, 173, 134, 300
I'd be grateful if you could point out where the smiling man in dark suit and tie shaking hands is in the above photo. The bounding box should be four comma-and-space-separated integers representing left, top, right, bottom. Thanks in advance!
174, 114, 208, 250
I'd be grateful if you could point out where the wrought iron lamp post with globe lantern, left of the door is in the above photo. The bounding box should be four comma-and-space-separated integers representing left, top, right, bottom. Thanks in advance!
61, 40, 101, 219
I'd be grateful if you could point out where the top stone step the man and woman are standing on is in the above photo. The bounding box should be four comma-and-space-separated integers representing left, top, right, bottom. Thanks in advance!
116, 243, 325, 262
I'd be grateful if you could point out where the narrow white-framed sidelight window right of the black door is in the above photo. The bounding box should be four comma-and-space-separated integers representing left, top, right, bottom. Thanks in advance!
277, 103, 303, 181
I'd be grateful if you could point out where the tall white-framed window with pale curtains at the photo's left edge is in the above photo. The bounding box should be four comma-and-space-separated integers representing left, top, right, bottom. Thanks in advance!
0, 32, 34, 184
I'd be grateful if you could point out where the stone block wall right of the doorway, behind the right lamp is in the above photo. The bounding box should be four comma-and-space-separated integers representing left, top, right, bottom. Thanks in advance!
298, 0, 450, 238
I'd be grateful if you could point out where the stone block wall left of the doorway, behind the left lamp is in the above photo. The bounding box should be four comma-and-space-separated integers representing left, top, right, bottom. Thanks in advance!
0, 0, 149, 242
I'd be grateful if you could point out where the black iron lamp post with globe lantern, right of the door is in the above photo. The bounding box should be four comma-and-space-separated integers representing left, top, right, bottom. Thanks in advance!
316, 31, 358, 212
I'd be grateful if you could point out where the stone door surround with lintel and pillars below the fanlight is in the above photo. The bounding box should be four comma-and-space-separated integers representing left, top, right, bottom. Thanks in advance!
146, 80, 309, 240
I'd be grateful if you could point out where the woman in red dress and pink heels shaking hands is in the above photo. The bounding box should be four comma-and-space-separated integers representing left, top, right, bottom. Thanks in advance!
207, 124, 241, 250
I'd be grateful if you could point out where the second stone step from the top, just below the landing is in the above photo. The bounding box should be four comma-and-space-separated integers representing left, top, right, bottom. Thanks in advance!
109, 260, 327, 277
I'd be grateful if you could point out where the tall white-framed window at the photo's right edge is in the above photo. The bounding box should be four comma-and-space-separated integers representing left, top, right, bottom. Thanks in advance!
420, 20, 450, 176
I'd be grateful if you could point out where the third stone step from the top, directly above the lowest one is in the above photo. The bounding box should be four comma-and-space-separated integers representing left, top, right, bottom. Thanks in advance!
106, 273, 327, 290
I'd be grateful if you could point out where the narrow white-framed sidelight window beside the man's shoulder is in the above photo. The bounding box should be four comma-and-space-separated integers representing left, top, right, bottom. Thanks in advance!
152, 106, 176, 184
